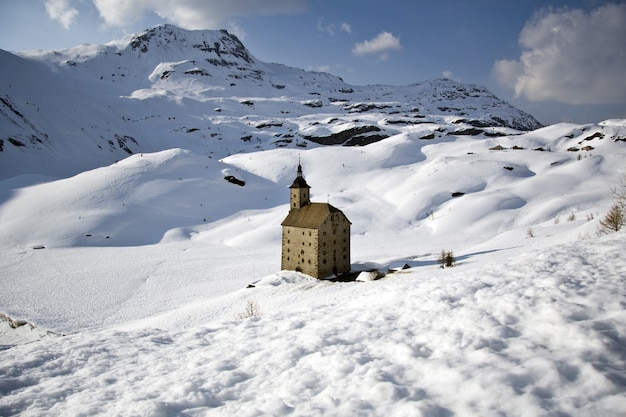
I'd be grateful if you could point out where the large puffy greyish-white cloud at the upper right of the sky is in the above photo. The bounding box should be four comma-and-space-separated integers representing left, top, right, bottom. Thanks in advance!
493, 3, 626, 104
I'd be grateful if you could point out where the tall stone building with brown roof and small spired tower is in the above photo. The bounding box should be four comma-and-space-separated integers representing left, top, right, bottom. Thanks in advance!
281, 165, 351, 278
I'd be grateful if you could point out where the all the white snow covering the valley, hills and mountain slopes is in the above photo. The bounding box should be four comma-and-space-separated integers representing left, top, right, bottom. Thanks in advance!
0, 27, 626, 417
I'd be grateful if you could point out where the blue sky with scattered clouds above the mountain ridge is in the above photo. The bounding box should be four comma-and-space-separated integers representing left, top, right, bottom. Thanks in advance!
0, 0, 626, 124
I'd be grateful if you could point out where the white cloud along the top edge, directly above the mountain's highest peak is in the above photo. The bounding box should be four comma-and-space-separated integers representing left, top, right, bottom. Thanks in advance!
93, 0, 306, 29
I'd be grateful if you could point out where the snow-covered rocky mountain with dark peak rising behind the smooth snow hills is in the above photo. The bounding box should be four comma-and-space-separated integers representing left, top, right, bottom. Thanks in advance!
0, 25, 540, 178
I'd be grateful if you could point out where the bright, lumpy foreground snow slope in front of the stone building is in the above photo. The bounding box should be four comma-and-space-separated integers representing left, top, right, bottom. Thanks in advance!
0, 233, 626, 416
